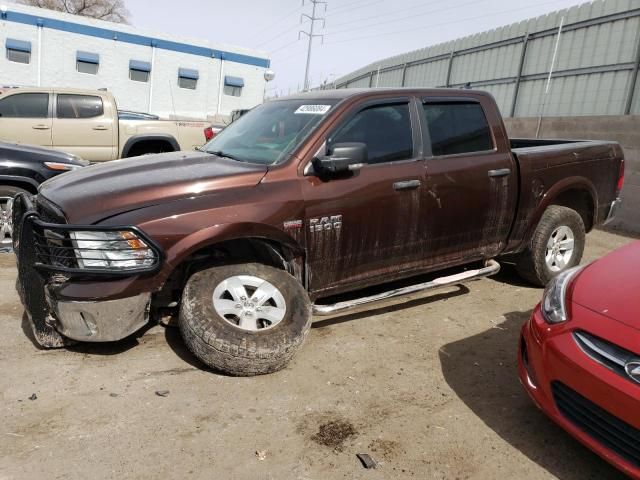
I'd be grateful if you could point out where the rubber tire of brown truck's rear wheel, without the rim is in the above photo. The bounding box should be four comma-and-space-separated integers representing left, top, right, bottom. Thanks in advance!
516, 205, 586, 287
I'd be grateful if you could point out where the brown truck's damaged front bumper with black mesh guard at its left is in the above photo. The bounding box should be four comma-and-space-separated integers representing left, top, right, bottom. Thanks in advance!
13, 195, 151, 347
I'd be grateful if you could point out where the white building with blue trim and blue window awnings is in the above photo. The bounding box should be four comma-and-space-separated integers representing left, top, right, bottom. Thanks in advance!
0, 0, 270, 118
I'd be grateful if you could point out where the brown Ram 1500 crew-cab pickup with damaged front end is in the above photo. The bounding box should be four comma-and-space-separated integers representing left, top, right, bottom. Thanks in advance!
13, 89, 624, 375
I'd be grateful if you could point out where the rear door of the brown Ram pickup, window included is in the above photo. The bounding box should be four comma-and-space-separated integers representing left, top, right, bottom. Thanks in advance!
421, 95, 518, 264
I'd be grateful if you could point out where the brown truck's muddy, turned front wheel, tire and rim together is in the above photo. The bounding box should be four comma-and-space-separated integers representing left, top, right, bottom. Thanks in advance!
178, 263, 311, 376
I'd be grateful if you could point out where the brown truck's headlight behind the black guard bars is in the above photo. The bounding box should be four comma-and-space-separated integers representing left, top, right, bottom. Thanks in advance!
69, 230, 158, 270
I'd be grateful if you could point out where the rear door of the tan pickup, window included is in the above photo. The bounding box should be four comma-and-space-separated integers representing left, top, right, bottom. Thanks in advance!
53, 93, 115, 162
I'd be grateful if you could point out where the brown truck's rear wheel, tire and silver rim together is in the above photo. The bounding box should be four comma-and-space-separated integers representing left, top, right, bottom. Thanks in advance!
516, 205, 585, 286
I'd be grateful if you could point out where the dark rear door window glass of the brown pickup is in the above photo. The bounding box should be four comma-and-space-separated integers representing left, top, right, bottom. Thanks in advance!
423, 102, 493, 156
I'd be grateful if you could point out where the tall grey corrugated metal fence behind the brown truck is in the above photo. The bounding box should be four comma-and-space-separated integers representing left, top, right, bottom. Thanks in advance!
324, 0, 640, 117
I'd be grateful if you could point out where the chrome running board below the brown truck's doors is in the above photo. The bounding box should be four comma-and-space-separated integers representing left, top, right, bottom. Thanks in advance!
313, 260, 500, 316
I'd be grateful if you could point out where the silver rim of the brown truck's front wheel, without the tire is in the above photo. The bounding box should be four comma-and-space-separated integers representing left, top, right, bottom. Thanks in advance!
213, 275, 287, 332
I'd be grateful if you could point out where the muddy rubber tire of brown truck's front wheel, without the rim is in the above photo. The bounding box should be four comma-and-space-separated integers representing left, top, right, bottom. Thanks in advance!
178, 263, 311, 376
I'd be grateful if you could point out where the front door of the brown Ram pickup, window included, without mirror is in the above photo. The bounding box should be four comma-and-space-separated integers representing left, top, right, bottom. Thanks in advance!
303, 98, 424, 293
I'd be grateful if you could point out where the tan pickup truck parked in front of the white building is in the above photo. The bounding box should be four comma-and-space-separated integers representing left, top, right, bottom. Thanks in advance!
0, 88, 209, 162
